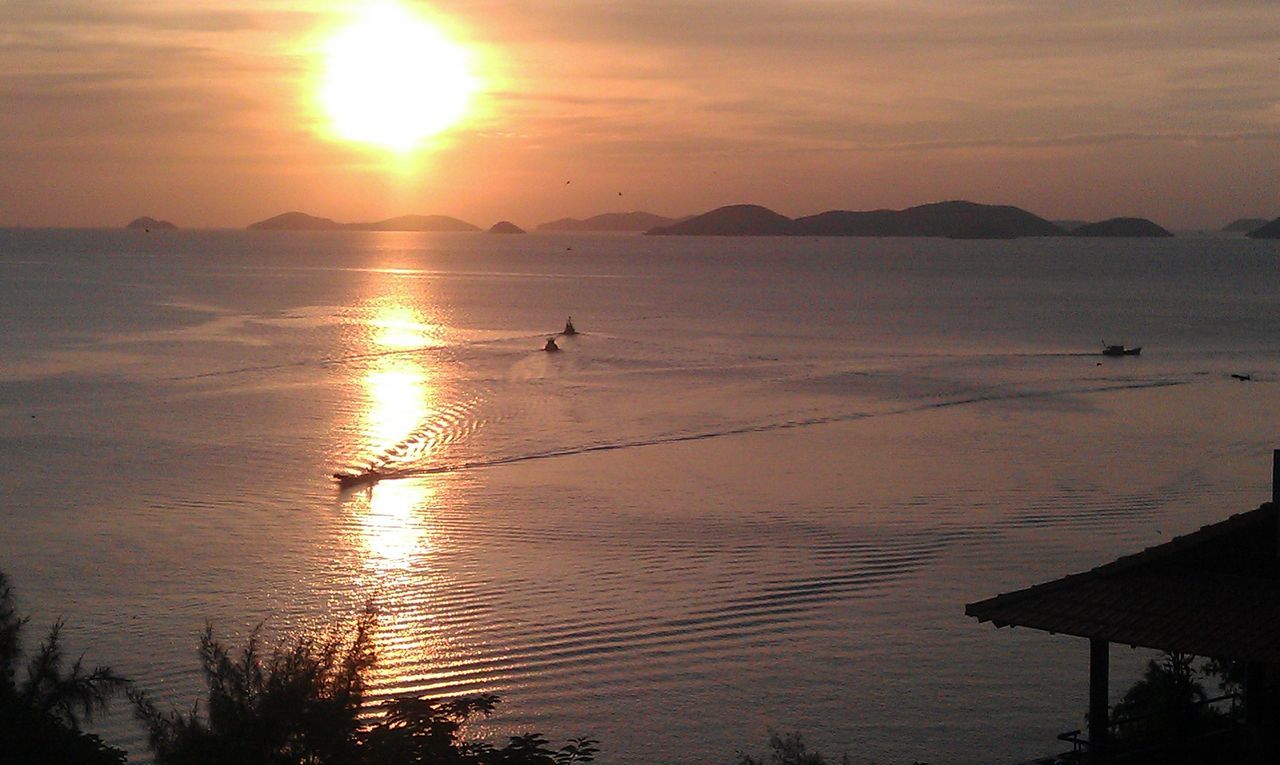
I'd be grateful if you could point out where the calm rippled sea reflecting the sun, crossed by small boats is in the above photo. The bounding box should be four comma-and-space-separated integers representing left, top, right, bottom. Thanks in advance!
0, 230, 1280, 764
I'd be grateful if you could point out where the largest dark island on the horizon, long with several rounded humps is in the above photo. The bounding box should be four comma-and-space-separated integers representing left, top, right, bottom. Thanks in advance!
649, 201, 1065, 239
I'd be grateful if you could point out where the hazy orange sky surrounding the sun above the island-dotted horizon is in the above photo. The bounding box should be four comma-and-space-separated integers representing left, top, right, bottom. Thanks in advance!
0, 0, 1280, 228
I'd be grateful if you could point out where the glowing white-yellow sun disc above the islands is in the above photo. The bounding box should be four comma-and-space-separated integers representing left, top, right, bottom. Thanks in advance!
319, 3, 477, 152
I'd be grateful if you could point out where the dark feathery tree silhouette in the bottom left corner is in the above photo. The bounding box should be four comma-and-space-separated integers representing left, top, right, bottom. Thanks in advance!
0, 572, 128, 765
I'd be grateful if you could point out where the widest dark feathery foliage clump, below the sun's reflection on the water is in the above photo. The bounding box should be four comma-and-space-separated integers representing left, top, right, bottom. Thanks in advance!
131, 609, 598, 765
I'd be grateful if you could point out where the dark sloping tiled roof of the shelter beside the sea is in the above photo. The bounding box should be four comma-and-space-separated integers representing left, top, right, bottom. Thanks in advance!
965, 503, 1280, 661
